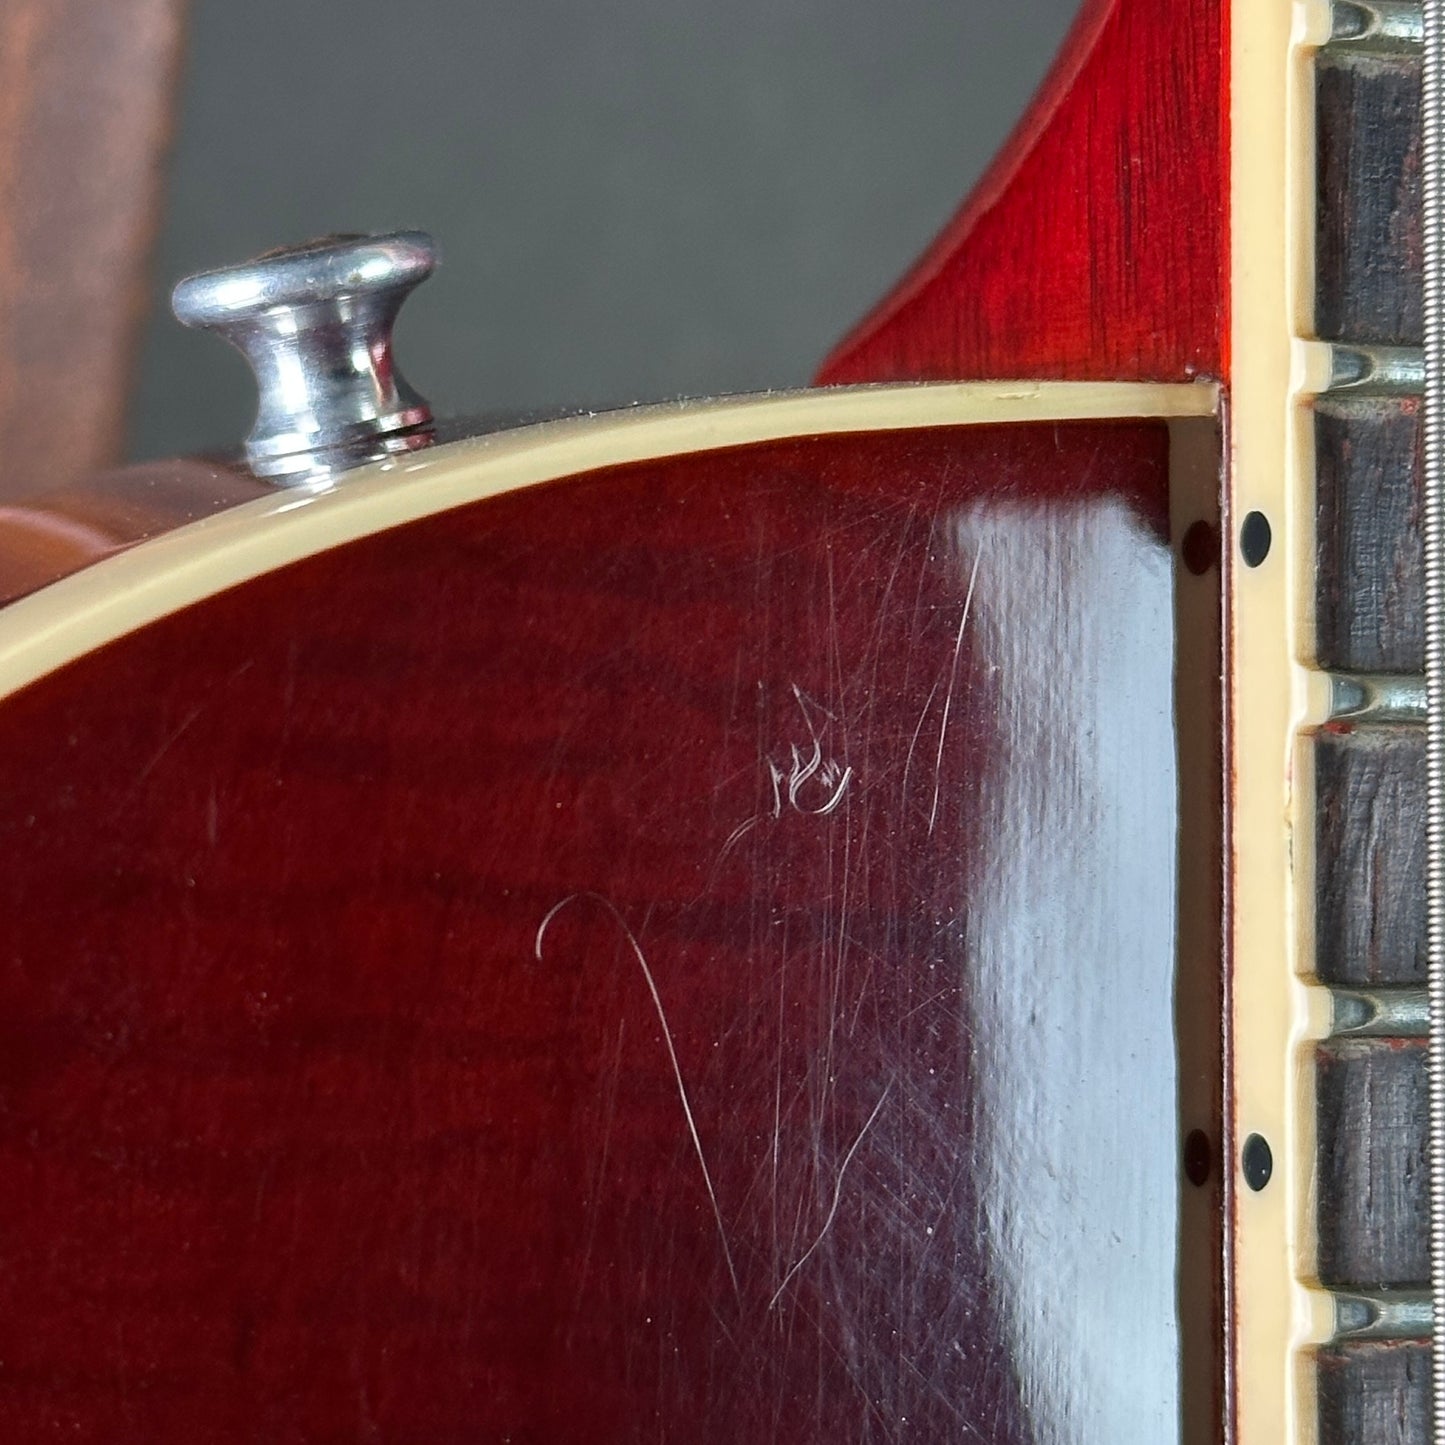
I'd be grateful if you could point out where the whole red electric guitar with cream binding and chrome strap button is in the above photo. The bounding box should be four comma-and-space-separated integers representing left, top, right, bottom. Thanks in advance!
0, 0, 1431, 1445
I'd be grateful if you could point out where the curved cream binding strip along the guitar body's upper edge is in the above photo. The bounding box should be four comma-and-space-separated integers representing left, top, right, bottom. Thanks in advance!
0, 381, 1218, 696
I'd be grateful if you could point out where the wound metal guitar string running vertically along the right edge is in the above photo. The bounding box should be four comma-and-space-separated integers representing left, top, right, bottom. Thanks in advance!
1422, 0, 1445, 1445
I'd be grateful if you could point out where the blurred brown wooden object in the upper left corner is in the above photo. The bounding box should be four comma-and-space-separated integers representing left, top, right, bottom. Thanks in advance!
0, 0, 185, 497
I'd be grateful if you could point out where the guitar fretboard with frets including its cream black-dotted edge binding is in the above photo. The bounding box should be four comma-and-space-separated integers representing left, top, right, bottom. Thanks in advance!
1230, 4, 1431, 1445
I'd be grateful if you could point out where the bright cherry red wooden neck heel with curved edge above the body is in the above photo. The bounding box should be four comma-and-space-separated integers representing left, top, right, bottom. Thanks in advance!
818, 0, 1225, 383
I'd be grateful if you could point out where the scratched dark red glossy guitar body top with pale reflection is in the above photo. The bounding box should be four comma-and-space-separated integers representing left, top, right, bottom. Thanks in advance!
0, 423, 1179, 1445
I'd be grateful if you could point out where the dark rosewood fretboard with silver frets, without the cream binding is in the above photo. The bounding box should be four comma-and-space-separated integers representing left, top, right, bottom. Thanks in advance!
1309, 4, 1429, 1445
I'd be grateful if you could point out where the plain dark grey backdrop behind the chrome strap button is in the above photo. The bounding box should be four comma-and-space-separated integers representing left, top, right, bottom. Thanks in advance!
131, 0, 1078, 458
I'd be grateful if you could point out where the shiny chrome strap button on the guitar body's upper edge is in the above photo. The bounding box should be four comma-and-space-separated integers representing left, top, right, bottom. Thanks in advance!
171, 231, 436, 483
